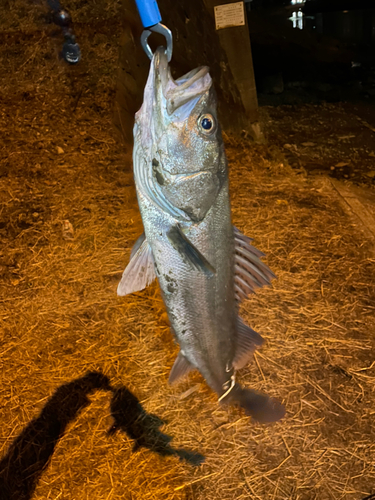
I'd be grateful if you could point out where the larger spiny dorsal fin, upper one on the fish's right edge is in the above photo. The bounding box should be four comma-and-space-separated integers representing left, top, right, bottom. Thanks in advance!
233, 227, 276, 302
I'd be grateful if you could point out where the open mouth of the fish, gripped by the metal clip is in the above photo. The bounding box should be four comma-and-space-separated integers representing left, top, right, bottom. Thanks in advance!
153, 47, 212, 115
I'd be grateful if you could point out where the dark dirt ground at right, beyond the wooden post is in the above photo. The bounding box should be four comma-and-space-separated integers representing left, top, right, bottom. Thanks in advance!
261, 101, 375, 188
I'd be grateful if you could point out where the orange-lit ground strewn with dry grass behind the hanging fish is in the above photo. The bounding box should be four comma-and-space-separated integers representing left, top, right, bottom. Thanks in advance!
0, 2, 375, 500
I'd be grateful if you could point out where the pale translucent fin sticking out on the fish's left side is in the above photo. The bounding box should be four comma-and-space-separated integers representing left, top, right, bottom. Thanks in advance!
117, 233, 156, 296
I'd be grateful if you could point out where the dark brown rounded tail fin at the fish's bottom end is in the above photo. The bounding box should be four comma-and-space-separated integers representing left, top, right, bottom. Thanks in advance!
233, 387, 285, 424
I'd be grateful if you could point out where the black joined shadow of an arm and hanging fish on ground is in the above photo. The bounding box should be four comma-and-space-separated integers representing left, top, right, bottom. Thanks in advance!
0, 372, 204, 500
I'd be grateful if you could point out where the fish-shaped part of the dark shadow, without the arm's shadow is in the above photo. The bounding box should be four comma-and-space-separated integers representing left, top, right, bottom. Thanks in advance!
108, 387, 204, 465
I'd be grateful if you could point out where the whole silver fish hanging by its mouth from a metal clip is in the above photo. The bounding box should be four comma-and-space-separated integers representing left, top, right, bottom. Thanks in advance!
117, 47, 285, 423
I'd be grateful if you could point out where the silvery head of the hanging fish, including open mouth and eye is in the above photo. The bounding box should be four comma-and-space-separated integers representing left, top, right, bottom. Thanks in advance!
134, 48, 228, 222
